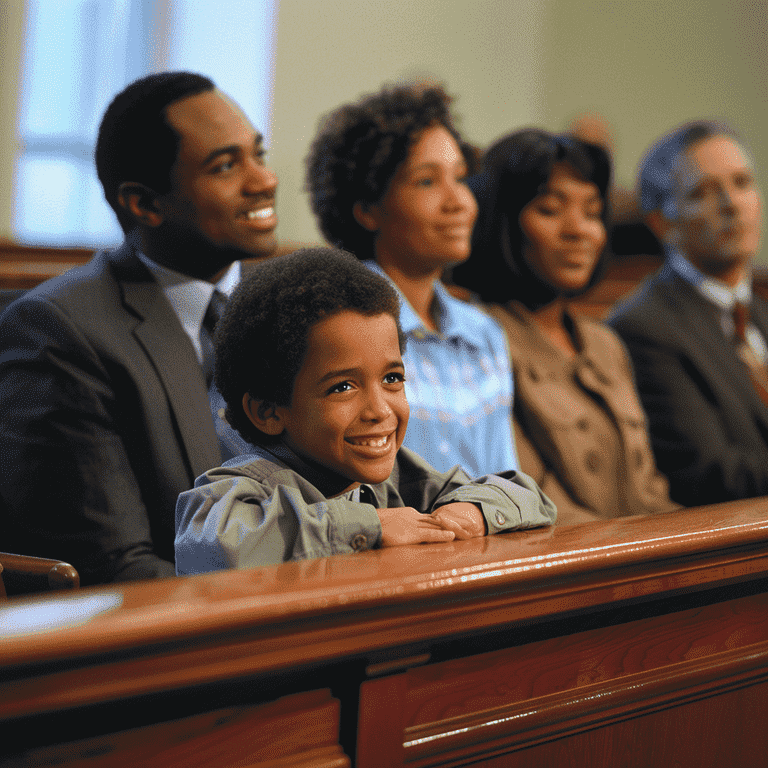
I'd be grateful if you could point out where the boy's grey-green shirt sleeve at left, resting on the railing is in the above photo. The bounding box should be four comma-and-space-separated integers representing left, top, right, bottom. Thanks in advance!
176, 473, 381, 575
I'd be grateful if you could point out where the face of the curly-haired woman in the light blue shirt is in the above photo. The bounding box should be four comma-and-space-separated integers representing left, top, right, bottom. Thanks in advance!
364, 125, 477, 274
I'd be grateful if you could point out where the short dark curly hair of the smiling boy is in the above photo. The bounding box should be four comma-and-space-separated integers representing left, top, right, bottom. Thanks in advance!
214, 248, 405, 445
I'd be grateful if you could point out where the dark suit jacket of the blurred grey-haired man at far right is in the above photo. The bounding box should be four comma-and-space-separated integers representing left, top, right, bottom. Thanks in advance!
608, 263, 768, 506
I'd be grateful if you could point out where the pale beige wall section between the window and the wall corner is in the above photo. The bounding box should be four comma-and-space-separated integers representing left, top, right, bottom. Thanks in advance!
270, 0, 546, 246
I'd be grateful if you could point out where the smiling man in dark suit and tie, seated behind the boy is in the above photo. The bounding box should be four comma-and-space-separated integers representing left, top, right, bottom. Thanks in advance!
0, 72, 277, 584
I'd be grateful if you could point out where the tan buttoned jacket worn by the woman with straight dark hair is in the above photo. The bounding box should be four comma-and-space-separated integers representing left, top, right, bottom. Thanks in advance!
488, 302, 677, 525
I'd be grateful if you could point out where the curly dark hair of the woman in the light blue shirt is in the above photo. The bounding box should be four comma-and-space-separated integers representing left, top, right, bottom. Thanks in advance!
306, 85, 475, 259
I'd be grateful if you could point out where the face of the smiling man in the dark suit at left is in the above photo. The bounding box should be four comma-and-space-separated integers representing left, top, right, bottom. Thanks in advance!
152, 90, 277, 277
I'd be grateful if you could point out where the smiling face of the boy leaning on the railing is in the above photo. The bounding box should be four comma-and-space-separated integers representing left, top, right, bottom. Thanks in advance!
274, 310, 409, 483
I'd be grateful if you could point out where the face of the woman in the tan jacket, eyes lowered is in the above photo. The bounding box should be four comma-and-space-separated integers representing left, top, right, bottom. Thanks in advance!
520, 163, 606, 292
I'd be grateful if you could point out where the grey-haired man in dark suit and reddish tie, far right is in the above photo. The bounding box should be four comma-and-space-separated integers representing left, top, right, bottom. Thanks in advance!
609, 121, 768, 505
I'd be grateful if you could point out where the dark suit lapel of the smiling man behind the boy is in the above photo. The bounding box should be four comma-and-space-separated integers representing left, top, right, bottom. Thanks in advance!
106, 246, 221, 477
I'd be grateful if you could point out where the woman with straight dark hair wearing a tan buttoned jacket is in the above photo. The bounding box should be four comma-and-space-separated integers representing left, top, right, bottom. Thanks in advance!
453, 129, 677, 525
